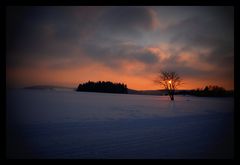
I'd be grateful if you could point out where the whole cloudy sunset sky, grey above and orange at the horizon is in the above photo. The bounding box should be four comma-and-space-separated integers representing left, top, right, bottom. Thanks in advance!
6, 6, 234, 90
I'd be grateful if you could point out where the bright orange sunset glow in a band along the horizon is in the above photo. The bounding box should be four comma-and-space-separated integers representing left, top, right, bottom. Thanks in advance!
6, 64, 234, 90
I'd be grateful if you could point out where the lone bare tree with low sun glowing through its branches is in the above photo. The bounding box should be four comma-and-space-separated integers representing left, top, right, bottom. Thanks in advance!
155, 71, 182, 101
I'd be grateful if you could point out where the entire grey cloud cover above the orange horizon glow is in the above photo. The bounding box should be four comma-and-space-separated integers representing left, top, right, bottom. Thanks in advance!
6, 6, 234, 89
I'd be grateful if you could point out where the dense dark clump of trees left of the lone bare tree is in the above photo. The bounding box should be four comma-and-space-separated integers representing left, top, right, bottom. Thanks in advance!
77, 81, 128, 93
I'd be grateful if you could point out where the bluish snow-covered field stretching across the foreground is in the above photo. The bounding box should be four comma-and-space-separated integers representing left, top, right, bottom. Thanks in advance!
6, 89, 234, 159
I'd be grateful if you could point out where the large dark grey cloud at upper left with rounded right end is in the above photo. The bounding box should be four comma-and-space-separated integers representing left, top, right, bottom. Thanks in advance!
7, 7, 159, 65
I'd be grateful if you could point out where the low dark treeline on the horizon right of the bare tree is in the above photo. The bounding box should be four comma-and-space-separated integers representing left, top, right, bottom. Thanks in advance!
176, 85, 234, 97
